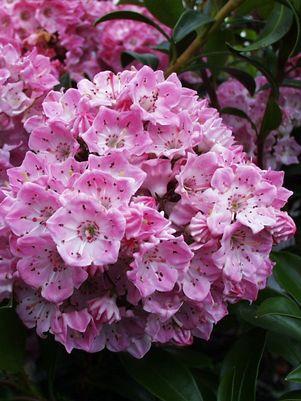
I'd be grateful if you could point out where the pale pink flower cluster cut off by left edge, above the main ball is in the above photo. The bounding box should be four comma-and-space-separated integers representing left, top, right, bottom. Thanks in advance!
0, 41, 58, 188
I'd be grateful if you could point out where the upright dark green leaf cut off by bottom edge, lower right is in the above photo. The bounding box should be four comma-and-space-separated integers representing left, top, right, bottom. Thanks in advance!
217, 331, 265, 401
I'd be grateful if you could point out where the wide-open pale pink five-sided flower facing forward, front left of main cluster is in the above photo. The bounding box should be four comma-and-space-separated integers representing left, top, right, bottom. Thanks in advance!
47, 196, 125, 266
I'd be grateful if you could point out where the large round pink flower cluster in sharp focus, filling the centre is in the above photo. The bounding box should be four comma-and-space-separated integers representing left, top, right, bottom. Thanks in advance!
0, 67, 295, 357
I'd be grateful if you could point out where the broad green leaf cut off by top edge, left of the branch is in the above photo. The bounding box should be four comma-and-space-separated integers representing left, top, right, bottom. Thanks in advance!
144, 0, 184, 27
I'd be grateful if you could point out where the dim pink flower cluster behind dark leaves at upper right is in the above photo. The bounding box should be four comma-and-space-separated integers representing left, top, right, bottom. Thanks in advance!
217, 76, 301, 169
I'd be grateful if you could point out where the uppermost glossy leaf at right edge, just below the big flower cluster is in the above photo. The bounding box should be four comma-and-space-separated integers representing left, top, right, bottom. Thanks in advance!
272, 252, 301, 304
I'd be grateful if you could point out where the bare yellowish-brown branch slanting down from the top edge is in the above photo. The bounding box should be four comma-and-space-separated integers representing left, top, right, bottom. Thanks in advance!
165, 0, 245, 77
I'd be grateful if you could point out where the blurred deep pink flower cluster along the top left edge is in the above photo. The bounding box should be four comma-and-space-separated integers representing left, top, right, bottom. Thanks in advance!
0, 0, 168, 80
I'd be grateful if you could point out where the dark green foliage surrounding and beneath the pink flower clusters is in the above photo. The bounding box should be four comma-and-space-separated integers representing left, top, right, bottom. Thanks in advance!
0, 0, 301, 401
